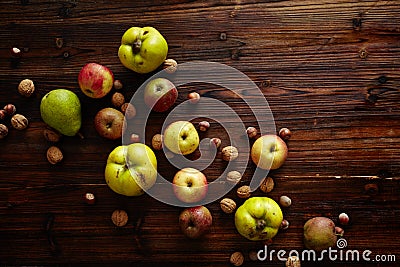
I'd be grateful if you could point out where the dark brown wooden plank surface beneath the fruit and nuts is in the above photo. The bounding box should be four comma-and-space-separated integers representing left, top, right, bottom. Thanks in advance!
0, 0, 400, 266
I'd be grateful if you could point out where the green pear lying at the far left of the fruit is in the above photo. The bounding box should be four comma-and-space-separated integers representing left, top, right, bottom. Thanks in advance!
40, 89, 82, 136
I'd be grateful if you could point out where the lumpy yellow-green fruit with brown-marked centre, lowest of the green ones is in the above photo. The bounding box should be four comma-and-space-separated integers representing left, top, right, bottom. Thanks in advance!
235, 197, 283, 241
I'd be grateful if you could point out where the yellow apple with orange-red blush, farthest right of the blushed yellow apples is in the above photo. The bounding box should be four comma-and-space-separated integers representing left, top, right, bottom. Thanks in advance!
250, 134, 288, 170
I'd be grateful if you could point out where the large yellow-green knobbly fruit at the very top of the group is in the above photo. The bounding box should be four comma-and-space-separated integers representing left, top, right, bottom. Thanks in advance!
118, 27, 168, 73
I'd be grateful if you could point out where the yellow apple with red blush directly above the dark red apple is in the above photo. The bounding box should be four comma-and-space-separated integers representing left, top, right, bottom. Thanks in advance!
172, 168, 208, 203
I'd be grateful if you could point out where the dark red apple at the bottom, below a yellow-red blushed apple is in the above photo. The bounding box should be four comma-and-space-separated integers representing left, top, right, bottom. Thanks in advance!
179, 206, 212, 239
